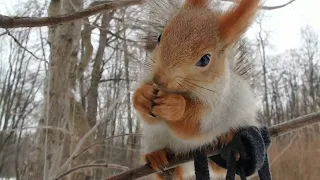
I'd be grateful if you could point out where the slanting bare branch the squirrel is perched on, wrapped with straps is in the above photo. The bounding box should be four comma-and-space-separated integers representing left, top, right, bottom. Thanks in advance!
105, 112, 320, 180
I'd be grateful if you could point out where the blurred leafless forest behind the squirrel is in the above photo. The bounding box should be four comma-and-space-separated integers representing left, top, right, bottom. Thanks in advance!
0, 0, 320, 180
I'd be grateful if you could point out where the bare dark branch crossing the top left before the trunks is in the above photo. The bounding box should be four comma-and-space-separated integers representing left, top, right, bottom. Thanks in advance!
0, 0, 142, 28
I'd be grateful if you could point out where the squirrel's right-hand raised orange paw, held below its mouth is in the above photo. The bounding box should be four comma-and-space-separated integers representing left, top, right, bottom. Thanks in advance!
152, 91, 186, 121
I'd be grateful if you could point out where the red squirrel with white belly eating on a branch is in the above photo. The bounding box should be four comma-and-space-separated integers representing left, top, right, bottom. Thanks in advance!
133, 0, 259, 179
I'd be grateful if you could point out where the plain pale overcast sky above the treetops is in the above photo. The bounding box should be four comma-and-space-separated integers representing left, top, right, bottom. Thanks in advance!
0, 0, 320, 53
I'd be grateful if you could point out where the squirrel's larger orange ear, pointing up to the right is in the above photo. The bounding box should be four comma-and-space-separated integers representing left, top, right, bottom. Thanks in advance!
218, 0, 259, 46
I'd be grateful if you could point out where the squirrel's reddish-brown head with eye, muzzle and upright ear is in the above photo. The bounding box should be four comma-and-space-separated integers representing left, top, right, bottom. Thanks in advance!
151, 0, 259, 95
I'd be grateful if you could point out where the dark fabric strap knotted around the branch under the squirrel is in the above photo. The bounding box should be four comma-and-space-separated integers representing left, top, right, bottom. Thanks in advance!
209, 127, 271, 180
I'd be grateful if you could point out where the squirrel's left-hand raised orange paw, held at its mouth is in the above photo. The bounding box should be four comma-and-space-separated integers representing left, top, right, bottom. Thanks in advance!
133, 84, 157, 123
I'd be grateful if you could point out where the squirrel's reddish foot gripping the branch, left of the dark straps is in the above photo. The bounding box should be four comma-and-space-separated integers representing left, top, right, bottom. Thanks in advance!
144, 149, 169, 171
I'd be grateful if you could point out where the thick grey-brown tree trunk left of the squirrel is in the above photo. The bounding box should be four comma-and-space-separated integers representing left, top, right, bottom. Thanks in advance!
25, 0, 82, 180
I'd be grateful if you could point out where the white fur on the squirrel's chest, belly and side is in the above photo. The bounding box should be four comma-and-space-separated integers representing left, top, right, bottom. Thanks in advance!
141, 73, 257, 154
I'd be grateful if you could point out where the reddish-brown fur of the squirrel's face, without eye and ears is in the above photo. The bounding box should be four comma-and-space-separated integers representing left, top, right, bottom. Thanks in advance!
153, 9, 225, 95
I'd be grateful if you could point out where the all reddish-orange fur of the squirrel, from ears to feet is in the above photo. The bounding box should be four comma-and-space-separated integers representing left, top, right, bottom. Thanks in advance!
133, 0, 259, 179
